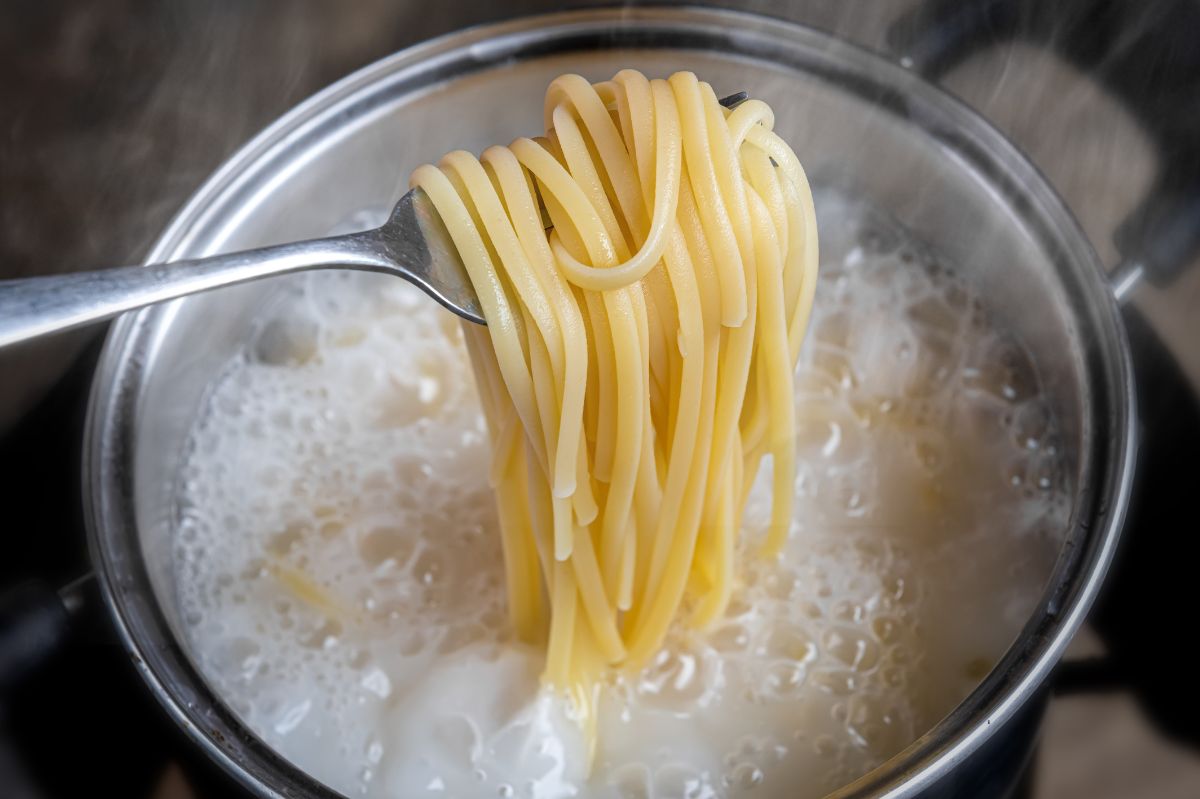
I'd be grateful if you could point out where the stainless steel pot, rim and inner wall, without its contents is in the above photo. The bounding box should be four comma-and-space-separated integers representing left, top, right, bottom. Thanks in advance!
84, 8, 1135, 797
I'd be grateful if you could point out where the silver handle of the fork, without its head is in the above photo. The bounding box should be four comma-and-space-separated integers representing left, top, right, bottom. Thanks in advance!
0, 230, 386, 347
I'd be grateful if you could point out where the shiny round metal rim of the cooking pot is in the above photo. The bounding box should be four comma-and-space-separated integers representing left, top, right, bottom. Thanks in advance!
83, 6, 1136, 799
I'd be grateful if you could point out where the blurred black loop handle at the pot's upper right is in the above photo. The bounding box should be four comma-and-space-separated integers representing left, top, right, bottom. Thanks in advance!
887, 0, 1200, 301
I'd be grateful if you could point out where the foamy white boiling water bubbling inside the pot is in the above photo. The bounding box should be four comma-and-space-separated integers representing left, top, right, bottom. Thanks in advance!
175, 197, 1069, 799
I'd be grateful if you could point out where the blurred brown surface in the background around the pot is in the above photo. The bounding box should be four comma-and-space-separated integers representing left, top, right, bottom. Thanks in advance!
0, 0, 1200, 799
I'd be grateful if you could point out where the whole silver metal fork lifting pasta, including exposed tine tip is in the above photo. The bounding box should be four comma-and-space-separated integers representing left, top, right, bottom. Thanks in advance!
0, 91, 746, 347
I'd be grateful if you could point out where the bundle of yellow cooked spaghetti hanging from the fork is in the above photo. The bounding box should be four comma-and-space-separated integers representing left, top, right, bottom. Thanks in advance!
412, 70, 817, 753
